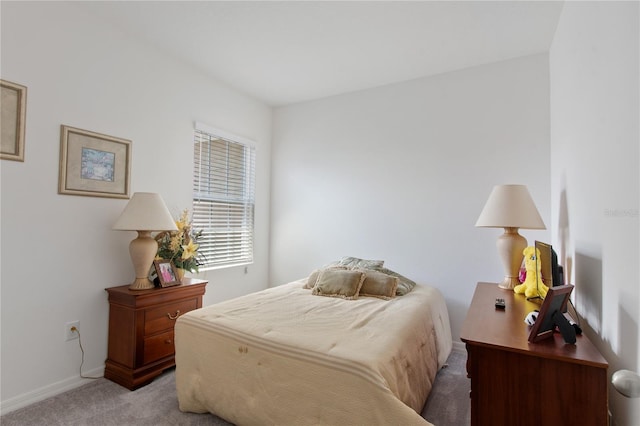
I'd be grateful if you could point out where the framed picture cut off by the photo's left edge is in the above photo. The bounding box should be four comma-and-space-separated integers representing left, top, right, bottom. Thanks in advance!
0, 80, 27, 161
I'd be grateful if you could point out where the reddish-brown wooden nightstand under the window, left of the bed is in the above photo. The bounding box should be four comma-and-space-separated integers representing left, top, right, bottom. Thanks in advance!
104, 278, 207, 390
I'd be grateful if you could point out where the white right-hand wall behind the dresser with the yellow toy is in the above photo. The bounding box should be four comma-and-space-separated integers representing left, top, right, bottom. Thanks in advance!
550, 2, 640, 426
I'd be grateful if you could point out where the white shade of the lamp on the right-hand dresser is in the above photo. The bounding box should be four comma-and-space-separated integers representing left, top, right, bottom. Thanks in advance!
476, 185, 546, 229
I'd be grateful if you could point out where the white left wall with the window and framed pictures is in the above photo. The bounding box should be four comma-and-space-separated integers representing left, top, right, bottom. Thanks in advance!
0, 2, 272, 411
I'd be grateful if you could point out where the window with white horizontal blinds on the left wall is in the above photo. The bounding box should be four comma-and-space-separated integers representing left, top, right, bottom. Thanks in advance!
193, 123, 255, 269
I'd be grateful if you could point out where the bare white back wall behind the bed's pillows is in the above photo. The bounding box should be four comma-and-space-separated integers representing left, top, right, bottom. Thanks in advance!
270, 54, 550, 342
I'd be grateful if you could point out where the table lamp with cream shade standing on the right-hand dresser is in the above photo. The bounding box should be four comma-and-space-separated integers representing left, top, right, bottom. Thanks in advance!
476, 185, 546, 290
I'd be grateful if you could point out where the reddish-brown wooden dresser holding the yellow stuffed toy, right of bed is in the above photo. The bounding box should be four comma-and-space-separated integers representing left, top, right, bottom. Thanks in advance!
461, 283, 608, 426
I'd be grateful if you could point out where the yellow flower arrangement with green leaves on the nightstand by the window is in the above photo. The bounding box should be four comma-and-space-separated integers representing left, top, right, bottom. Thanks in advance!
156, 209, 204, 272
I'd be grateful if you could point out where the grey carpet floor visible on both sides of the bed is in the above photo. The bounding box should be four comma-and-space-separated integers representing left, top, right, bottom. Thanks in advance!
0, 351, 471, 426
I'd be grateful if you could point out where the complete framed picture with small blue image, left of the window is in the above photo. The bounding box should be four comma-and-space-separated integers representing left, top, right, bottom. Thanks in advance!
58, 125, 131, 198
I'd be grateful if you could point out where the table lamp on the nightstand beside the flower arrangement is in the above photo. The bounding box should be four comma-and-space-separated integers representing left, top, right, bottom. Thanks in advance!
113, 192, 178, 290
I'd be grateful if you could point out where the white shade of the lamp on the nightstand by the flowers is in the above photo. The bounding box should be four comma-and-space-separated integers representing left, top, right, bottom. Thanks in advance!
113, 192, 178, 231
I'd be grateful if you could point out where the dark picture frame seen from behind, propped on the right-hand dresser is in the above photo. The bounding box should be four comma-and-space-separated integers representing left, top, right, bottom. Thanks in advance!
529, 284, 576, 343
